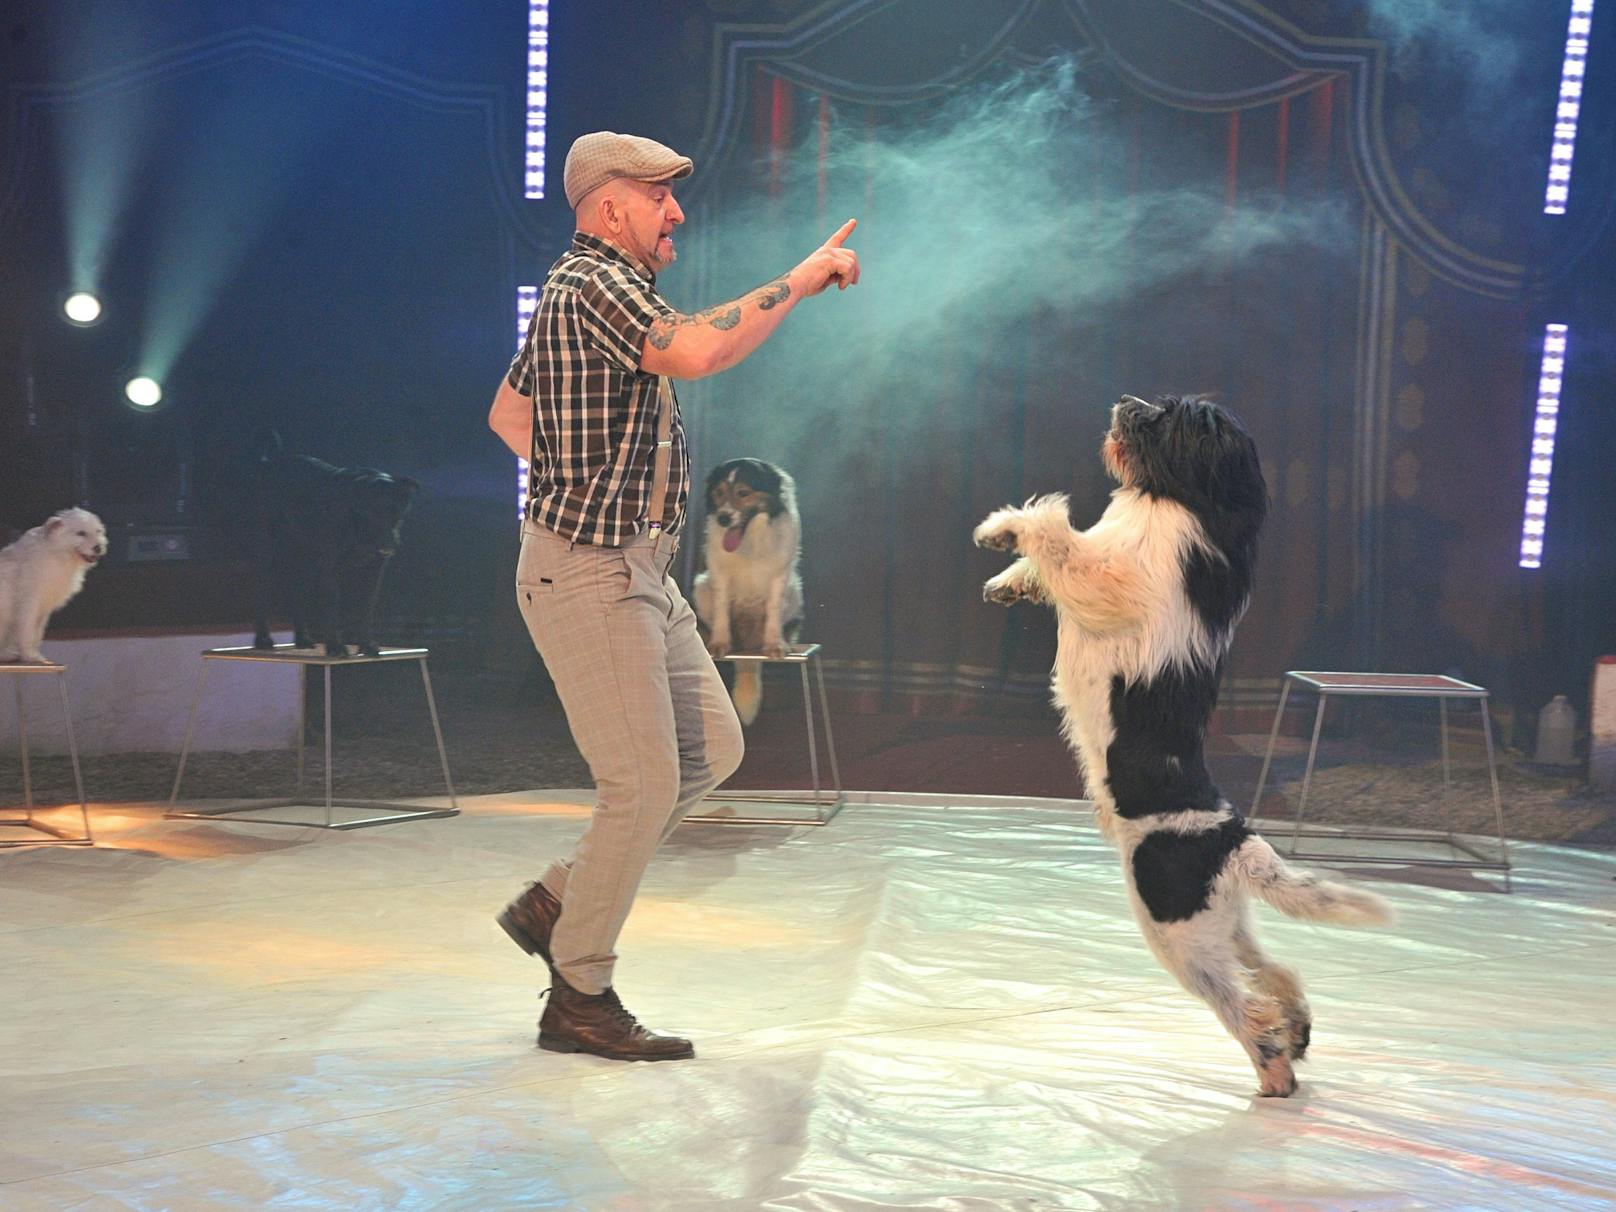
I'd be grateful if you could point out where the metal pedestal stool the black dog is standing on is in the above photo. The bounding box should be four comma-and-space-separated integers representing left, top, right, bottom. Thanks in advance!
163, 645, 461, 829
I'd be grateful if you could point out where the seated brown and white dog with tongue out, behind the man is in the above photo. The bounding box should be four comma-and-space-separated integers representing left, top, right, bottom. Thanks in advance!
693, 459, 803, 724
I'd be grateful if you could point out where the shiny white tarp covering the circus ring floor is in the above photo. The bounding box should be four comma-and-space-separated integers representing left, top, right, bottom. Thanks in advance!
0, 792, 1616, 1212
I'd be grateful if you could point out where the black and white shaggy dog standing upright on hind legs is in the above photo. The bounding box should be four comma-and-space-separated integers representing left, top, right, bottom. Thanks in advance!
974, 396, 1391, 1097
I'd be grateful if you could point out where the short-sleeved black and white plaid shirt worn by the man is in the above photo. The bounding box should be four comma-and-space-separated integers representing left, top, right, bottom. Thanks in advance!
506, 231, 690, 546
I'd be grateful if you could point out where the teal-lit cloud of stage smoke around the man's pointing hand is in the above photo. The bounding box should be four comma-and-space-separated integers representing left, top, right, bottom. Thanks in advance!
681, 58, 1354, 461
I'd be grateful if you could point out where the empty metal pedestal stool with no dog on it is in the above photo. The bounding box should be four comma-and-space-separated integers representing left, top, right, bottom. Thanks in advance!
1251, 669, 1509, 887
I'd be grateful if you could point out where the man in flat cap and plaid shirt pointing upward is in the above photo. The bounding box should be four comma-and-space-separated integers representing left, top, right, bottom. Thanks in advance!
488, 131, 858, 1060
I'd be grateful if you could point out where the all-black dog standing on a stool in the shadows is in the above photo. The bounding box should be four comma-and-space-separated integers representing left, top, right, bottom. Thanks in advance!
252, 433, 417, 656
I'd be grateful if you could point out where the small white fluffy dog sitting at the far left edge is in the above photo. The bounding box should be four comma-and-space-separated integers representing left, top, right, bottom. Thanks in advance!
0, 509, 107, 664
